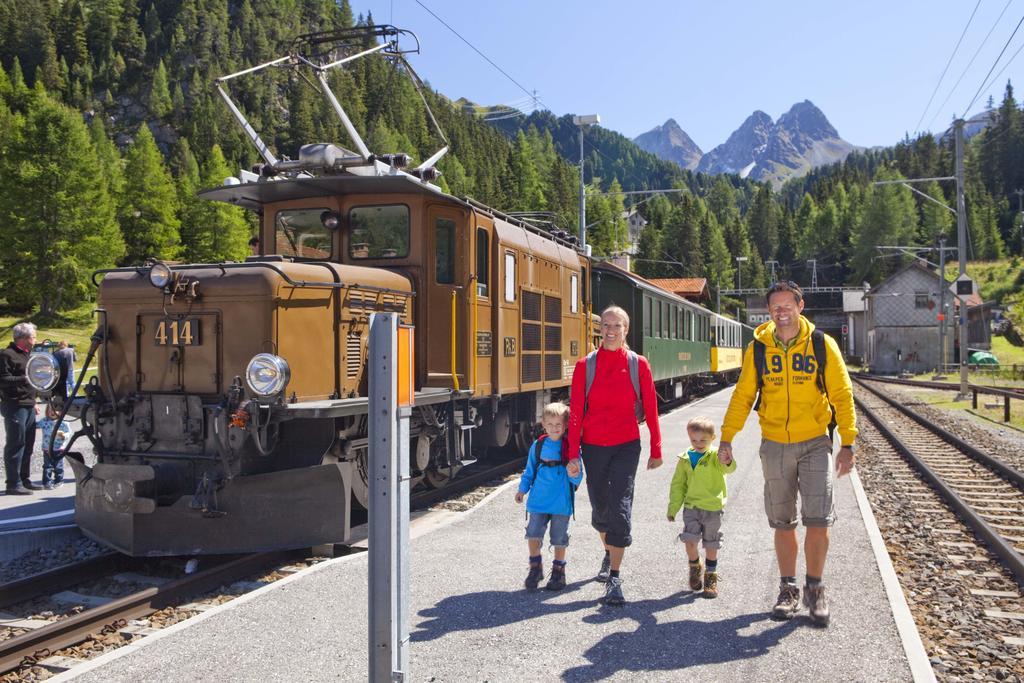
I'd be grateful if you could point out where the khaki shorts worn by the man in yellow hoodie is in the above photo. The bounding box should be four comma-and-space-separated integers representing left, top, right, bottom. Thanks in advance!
761, 435, 836, 528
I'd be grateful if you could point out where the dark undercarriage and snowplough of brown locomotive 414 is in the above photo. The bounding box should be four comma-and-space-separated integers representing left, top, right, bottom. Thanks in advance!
69, 386, 547, 556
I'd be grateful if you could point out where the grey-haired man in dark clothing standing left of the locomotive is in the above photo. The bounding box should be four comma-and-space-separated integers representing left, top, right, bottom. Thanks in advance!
0, 323, 39, 496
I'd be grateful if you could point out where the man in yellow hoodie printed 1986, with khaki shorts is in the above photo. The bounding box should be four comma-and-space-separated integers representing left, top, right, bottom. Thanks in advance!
719, 282, 857, 627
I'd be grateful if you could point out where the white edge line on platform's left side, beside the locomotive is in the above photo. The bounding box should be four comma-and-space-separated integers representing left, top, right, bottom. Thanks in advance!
47, 478, 519, 683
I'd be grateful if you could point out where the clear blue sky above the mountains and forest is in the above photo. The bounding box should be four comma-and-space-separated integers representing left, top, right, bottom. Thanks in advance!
350, 0, 1024, 152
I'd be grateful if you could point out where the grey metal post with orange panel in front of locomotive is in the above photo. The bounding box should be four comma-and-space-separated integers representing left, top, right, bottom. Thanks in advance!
367, 313, 409, 683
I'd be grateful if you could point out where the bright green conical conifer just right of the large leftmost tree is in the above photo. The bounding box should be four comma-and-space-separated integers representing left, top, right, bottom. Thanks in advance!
119, 124, 181, 265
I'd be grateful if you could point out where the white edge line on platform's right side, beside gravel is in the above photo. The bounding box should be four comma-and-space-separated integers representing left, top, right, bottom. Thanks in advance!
850, 470, 935, 683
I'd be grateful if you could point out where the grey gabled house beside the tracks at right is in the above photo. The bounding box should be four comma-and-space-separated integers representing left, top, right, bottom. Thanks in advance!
863, 261, 991, 374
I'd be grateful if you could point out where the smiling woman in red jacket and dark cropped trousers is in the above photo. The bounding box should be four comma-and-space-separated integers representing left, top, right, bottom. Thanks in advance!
568, 306, 662, 605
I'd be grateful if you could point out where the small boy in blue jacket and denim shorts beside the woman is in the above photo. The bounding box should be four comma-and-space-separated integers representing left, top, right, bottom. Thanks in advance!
515, 403, 583, 591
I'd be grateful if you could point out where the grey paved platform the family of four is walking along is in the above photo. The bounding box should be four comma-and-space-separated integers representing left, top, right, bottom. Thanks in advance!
59, 390, 933, 683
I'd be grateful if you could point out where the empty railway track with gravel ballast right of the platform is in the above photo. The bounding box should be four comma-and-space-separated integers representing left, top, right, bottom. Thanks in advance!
855, 381, 1024, 680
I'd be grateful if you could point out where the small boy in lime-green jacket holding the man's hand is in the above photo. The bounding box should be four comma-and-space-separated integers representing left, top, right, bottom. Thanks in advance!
669, 417, 736, 598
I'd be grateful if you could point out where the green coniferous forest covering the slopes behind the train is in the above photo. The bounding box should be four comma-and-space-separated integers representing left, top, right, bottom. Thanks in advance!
0, 0, 1024, 314
